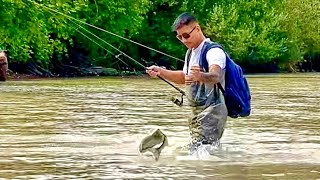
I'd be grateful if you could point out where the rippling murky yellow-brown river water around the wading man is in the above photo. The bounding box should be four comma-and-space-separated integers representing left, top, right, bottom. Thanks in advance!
0, 73, 320, 180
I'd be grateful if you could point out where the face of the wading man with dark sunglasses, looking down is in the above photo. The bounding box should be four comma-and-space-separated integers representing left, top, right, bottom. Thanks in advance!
176, 23, 199, 49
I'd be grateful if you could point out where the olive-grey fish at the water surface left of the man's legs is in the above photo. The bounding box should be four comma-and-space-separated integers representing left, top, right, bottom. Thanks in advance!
139, 129, 168, 161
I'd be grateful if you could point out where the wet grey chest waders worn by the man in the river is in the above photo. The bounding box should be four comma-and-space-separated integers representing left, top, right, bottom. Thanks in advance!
186, 45, 228, 151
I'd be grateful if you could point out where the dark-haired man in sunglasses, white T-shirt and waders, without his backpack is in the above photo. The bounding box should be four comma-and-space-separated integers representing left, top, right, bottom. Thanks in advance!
147, 13, 228, 153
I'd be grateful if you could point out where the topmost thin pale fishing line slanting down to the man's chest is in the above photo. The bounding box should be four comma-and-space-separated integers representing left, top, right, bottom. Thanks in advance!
28, 0, 184, 62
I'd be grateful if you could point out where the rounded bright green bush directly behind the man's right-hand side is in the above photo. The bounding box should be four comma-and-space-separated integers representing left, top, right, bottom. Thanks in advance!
206, 0, 287, 64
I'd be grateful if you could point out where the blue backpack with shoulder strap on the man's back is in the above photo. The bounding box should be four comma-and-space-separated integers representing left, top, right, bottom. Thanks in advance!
200, 42, 251, 118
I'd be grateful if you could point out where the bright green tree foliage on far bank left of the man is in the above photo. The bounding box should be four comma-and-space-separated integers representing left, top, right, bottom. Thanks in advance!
0, 0, 149, 65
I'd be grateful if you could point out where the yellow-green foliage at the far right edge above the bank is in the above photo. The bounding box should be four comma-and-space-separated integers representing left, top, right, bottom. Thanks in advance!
282, 0, 320, 61
